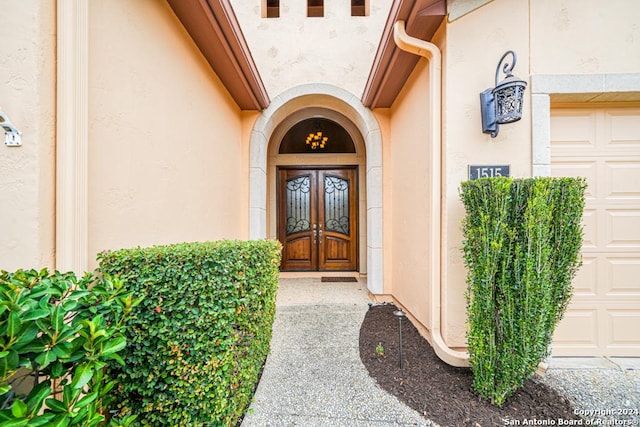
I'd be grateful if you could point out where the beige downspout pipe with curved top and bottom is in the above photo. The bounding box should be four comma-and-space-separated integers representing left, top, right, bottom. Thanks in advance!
393, 21, 469, 367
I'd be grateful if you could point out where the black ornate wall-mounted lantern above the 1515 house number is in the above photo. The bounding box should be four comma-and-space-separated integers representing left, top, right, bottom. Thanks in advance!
480, 50, 527, 138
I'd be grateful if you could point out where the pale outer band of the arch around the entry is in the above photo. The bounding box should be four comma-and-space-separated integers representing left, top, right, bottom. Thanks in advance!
249, 84, 383, 294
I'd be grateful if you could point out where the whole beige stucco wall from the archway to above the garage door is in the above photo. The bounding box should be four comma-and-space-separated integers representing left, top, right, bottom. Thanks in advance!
385, 0, 640, 347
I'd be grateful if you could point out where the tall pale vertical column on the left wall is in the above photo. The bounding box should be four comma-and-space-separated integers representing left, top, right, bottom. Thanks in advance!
56, 0, 89, 274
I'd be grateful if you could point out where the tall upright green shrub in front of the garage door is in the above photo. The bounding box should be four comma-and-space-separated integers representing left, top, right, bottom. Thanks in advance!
461, 178, 586, 406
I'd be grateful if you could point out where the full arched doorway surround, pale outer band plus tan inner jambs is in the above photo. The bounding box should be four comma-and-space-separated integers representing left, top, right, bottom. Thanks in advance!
249, 84, 383, 294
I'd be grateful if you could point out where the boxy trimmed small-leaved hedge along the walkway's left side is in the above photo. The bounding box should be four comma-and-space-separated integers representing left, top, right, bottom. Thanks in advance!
99, 240, 280, 426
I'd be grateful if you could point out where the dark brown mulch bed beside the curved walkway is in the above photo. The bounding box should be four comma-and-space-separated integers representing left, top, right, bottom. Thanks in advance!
360, 305, 580, 427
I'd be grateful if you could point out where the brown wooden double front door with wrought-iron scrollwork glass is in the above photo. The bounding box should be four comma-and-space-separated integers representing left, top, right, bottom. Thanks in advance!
277, 167, 358, 271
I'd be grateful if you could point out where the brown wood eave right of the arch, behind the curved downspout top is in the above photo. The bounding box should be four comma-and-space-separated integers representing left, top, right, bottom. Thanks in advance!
361, 0, 446, 109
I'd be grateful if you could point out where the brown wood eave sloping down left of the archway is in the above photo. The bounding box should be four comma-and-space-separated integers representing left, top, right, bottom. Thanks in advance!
167, 0, 270, 110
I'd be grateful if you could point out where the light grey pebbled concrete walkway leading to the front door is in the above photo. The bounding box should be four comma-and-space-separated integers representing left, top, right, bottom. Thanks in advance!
242, 278, 435, 427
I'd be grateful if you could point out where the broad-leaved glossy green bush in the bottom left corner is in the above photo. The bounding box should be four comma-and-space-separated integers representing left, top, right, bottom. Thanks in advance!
0, 269, 137, 427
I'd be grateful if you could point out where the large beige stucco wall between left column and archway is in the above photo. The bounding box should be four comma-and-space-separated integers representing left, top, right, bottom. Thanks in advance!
89, 0, 251, 268
